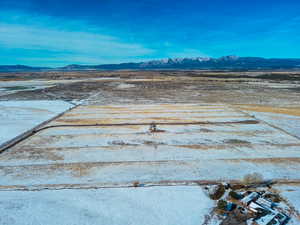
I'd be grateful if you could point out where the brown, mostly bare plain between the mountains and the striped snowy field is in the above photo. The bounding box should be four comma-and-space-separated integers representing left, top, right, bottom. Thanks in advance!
0, 71, 300, 106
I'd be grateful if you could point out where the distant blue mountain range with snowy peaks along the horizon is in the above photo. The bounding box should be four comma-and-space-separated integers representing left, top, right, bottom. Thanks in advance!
0, 56, 300, 71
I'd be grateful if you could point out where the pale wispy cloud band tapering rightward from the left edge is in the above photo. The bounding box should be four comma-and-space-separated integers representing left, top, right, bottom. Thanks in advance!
0, 23, 151, 56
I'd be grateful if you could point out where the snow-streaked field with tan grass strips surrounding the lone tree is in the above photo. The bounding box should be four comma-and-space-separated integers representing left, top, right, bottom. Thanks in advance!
0, 104, 300, 189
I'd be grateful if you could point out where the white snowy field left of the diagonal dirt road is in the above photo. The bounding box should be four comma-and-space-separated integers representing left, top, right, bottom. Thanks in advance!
0, 101, 72, 146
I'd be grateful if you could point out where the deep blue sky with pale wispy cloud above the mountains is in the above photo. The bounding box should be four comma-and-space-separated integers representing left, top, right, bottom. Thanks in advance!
0, 0, 300, 66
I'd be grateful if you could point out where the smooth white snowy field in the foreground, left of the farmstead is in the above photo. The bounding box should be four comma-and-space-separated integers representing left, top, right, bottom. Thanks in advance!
0, 187, 214, 225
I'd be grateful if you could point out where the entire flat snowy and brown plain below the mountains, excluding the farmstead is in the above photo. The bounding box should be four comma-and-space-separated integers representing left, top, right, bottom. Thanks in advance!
0, 71, 300, 225
